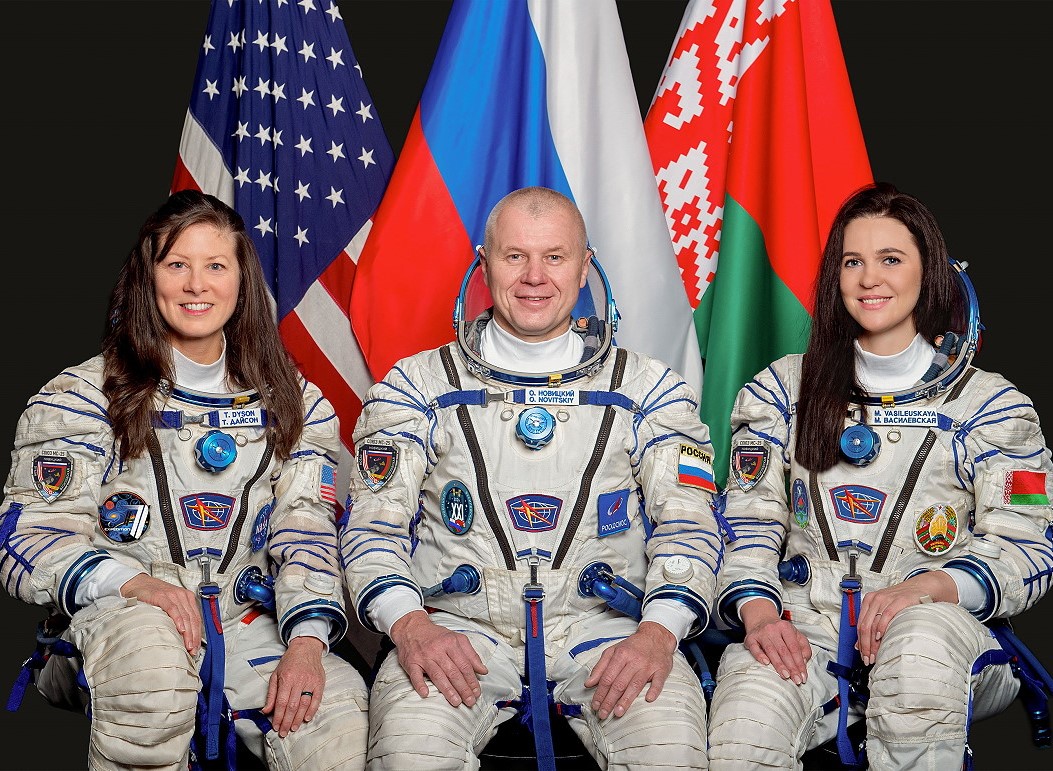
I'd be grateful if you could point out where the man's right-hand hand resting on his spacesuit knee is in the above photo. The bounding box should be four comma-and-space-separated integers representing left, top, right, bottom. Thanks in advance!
584, 621, 676, 720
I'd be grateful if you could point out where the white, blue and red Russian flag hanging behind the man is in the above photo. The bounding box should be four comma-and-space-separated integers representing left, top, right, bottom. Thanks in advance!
351, 0, 701, 390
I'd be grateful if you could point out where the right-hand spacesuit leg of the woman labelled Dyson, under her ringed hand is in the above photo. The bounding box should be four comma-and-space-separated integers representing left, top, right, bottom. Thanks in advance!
265, 655, 369, 771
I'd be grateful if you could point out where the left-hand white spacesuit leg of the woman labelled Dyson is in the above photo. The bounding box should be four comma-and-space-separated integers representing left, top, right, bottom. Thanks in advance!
69, 597, 201, 767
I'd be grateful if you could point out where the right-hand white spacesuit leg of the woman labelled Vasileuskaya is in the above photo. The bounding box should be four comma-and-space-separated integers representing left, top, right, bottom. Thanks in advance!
867, 602, 1019, 769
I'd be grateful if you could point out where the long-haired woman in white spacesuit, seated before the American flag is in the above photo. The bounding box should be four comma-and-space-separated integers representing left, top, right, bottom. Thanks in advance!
0, 191, 367, 769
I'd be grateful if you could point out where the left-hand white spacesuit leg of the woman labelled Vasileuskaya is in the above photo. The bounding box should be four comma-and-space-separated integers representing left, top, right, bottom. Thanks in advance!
709, 644, 818, 768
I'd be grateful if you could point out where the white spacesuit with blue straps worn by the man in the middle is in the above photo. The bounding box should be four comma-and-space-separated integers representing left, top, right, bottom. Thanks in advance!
341, 259, 721, 769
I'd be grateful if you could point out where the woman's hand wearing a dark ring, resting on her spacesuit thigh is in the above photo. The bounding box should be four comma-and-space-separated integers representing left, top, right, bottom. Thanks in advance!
263, 635, 325, 738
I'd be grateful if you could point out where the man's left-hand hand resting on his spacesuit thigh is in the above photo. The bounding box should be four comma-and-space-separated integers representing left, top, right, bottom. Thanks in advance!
391, 610, 488, 707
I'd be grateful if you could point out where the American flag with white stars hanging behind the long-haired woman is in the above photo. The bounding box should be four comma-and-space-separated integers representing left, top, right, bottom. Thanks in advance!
172, 0, 394, 451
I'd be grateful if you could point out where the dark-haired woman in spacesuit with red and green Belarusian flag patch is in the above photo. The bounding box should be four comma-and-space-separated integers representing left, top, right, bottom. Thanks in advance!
710, 183, 1053, 769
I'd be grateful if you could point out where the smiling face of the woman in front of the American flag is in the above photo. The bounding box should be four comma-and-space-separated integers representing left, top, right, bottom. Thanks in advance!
154, 222, 241, 364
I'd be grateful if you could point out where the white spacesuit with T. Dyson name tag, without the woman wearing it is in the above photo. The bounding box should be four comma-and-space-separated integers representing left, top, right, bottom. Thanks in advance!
0, 356, 367, 769
